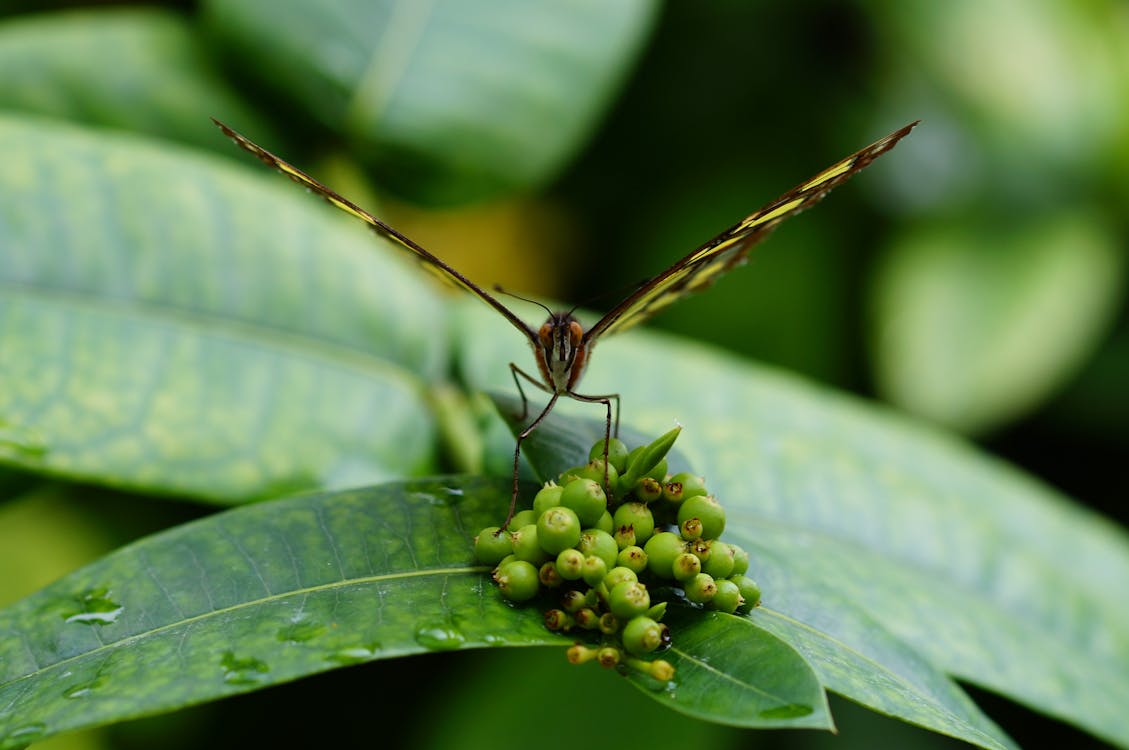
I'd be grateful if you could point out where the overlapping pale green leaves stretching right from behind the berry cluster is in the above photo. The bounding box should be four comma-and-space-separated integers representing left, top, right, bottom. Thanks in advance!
456, 302, 1129, 747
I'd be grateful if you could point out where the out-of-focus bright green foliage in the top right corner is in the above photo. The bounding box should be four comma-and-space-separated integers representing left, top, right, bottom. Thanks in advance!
873, 0, 1129, 176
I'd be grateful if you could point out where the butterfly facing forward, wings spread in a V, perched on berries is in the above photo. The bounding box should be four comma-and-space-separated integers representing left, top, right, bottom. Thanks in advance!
212, 117, 919, 529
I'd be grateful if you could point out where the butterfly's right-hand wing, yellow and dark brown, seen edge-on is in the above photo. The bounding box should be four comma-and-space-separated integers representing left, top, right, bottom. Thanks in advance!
584, 122, 917, 345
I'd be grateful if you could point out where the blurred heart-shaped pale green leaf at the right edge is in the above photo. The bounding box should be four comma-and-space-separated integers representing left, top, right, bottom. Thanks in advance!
873, 213, 1124, 433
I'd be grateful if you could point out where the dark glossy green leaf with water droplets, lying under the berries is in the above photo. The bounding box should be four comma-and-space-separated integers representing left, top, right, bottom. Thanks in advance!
0, 478, 829, 747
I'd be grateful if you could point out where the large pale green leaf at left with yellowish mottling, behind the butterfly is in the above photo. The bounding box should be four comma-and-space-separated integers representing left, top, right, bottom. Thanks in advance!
0, 117, 446, 502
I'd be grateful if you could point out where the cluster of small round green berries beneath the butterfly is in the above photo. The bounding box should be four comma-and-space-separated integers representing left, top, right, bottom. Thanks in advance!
474, 427, 761, 681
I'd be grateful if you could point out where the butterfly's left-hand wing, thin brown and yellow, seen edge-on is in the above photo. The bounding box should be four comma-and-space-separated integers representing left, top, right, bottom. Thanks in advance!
212, 117, 537, 345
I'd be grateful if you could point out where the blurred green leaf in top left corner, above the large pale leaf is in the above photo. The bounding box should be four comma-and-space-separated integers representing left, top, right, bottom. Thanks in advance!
0, 8, 284, 156
